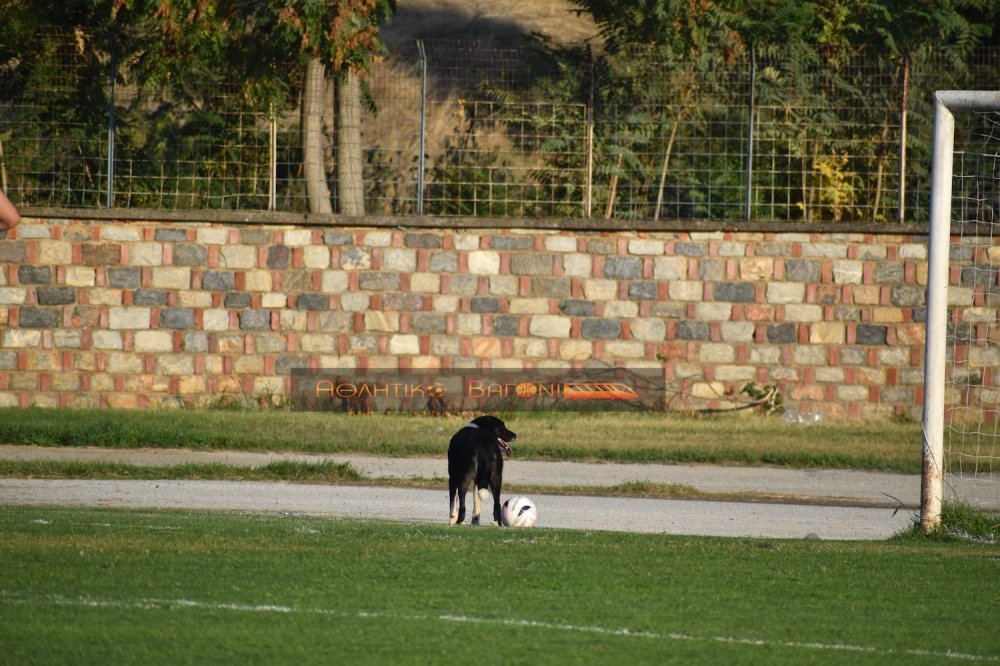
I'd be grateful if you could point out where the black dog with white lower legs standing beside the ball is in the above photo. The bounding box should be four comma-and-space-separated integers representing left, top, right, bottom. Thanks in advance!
448, 416, 517, 525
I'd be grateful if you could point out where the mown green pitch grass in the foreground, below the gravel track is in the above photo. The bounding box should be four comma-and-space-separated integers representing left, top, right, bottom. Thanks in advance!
0, 506, 1000, 666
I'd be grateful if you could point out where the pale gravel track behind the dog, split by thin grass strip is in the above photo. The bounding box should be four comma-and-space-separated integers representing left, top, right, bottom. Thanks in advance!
0, 446, 920, 539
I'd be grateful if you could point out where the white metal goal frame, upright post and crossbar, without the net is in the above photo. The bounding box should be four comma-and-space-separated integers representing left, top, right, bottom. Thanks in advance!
920, 90, 1000, 531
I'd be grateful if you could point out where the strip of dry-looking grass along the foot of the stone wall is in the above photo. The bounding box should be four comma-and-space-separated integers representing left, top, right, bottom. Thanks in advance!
0, 409, 920, 473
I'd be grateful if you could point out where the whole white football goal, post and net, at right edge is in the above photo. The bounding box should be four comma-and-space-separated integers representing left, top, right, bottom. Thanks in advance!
921, 91, 1000, 530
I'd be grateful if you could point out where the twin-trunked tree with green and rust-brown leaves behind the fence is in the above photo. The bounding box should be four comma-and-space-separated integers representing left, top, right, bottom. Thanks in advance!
104, 0, 392, 215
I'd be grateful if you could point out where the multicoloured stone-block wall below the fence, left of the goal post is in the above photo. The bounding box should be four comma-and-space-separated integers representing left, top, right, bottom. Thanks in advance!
0, 218, 948, 419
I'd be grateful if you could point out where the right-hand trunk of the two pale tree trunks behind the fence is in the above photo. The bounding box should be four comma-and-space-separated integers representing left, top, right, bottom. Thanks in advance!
337, 68, 365, 215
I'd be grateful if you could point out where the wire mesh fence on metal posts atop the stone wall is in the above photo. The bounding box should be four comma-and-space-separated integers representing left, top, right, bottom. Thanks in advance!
0, 34, 1000, 222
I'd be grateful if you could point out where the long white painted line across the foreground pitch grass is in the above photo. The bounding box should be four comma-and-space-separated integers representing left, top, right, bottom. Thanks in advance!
0, 590, 1000, 663
